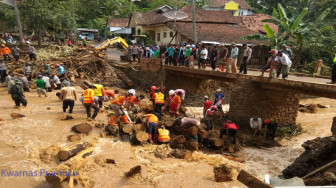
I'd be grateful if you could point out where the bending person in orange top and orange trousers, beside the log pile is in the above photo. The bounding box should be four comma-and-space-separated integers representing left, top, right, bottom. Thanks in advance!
109, 93, 130, 126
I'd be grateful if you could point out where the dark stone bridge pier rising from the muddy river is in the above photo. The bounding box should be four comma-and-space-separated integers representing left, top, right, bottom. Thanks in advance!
229, 79, 300, 127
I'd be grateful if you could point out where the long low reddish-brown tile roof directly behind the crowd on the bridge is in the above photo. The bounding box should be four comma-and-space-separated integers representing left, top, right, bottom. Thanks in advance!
167, 22, 267, 45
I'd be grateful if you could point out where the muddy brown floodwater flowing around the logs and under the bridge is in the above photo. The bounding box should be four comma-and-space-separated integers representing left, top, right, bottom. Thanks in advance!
0, 84, 336, 188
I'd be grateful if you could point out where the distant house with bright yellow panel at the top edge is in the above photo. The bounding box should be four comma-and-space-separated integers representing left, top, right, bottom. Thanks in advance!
204, 0, 253, 16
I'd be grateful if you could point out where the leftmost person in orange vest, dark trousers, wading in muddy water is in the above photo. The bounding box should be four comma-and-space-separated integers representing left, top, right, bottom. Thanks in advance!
83, 85, 99, 120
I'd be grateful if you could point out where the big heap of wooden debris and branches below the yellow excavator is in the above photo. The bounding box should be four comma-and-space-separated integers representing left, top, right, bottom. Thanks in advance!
7, 45, 133, 88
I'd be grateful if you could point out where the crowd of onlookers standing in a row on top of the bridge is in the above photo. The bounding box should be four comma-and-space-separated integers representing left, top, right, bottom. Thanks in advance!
129, 43, 293, 79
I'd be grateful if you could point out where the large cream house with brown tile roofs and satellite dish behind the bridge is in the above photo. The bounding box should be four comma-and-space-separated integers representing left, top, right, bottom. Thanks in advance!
128, 5, 262, 45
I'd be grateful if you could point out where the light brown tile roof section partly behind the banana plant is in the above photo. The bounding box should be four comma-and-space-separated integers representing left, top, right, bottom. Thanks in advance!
237, 14, 278, 34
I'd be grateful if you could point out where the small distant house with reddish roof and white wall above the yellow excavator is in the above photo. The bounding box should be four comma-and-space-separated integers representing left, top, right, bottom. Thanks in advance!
106, 18, 132, 35
